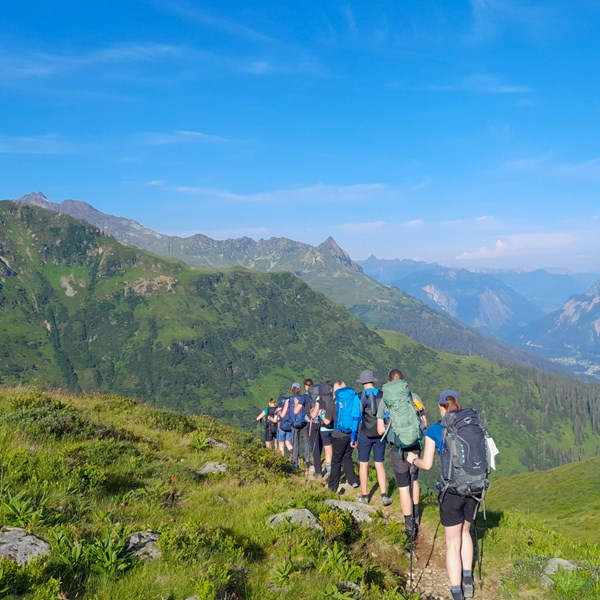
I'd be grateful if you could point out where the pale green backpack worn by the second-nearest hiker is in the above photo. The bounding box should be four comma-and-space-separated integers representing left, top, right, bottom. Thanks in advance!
383, 379, 423, 450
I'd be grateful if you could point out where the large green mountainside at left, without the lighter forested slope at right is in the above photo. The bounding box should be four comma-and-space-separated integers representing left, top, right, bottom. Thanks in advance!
0, 202, 406, 425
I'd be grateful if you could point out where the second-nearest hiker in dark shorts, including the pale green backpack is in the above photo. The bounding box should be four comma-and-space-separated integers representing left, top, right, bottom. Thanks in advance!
377, 369, 424, 541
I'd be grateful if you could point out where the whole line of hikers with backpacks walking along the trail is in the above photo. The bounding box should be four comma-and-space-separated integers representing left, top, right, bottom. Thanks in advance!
256, 369, 495, 600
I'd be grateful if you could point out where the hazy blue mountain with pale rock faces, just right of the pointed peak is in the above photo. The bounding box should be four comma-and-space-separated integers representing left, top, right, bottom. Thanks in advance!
360, 256, 544, 338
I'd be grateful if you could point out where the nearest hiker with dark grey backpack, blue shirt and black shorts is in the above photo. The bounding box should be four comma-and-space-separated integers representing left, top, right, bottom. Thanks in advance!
408, 390, 489, 600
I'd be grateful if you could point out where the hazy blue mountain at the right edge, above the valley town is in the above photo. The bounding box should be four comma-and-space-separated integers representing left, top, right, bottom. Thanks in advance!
513, 281, 600, 378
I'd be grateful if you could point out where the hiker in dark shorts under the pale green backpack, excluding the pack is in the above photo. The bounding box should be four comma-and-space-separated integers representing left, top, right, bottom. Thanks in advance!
377, 369, 424, 540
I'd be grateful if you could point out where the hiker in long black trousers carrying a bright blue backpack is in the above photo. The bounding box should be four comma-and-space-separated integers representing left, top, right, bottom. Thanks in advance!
323, 380, 360, 494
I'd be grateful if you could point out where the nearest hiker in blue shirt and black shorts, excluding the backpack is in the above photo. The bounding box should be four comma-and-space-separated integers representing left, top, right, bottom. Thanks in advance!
407, 390, 479, 600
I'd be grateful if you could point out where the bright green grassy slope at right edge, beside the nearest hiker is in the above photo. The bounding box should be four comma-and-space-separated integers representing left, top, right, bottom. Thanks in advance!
488, 456, 600, 543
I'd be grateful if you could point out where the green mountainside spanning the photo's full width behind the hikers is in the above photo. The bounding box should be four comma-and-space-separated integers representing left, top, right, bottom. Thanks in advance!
0, 201, 600, 474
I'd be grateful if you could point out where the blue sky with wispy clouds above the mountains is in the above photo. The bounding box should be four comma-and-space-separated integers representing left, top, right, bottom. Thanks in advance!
0, 0, 600, 271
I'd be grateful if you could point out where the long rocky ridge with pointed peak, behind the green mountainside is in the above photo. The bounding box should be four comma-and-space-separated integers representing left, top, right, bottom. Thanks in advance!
19, 193, 564, 372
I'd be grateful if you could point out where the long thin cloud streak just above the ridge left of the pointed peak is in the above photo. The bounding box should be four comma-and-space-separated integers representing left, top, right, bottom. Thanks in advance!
176, 183, 391, 204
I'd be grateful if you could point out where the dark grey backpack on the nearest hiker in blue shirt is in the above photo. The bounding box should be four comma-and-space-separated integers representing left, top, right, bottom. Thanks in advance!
437, 408, 490, 499
